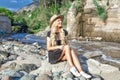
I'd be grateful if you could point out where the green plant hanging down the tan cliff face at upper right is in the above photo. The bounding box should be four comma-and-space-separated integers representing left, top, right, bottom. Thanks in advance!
93, 0, 109, 21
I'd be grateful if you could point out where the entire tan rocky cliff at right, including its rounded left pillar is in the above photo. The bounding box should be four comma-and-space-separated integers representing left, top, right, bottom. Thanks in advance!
67, 0, 120, 42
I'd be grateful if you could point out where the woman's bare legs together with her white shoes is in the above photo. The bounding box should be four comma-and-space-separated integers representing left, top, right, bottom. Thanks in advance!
60, 45, 91, 78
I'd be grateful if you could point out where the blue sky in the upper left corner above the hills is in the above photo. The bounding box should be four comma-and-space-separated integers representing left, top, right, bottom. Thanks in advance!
0, 0, 33, 11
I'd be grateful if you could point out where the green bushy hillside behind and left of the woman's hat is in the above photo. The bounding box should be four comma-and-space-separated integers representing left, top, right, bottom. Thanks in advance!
14, 0, 71, 33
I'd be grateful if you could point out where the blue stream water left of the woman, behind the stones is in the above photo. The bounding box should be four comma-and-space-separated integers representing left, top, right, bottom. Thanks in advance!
6, 33, 46, 48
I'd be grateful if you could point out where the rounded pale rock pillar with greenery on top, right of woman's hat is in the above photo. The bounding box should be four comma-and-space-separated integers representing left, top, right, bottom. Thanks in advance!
67, 0, 84, 38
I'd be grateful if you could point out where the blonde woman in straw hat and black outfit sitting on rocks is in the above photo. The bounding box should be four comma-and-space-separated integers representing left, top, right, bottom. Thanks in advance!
47, 15, 91, 78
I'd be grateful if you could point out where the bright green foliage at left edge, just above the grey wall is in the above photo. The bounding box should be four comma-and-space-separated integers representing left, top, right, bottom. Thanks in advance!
0, 8, 14, 24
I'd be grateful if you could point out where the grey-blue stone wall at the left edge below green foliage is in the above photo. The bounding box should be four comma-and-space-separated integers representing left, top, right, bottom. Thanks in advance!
0, 15, 12, 34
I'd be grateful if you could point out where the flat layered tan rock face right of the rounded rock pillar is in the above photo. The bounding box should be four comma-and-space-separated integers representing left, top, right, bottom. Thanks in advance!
83, 0, 120, 41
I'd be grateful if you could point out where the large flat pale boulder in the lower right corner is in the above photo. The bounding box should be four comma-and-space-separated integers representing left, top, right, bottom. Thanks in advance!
87, 59, 120, 80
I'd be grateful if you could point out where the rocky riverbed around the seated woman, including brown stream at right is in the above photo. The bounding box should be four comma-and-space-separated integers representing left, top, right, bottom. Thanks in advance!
0, 33, 120, 80
